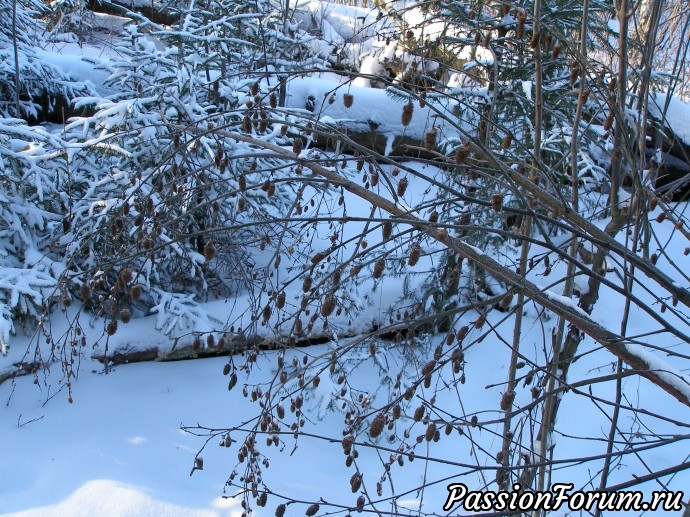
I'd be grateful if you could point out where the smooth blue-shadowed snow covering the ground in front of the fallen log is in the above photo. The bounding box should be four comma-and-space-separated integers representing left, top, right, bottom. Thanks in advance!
0, 204, 690, 517
